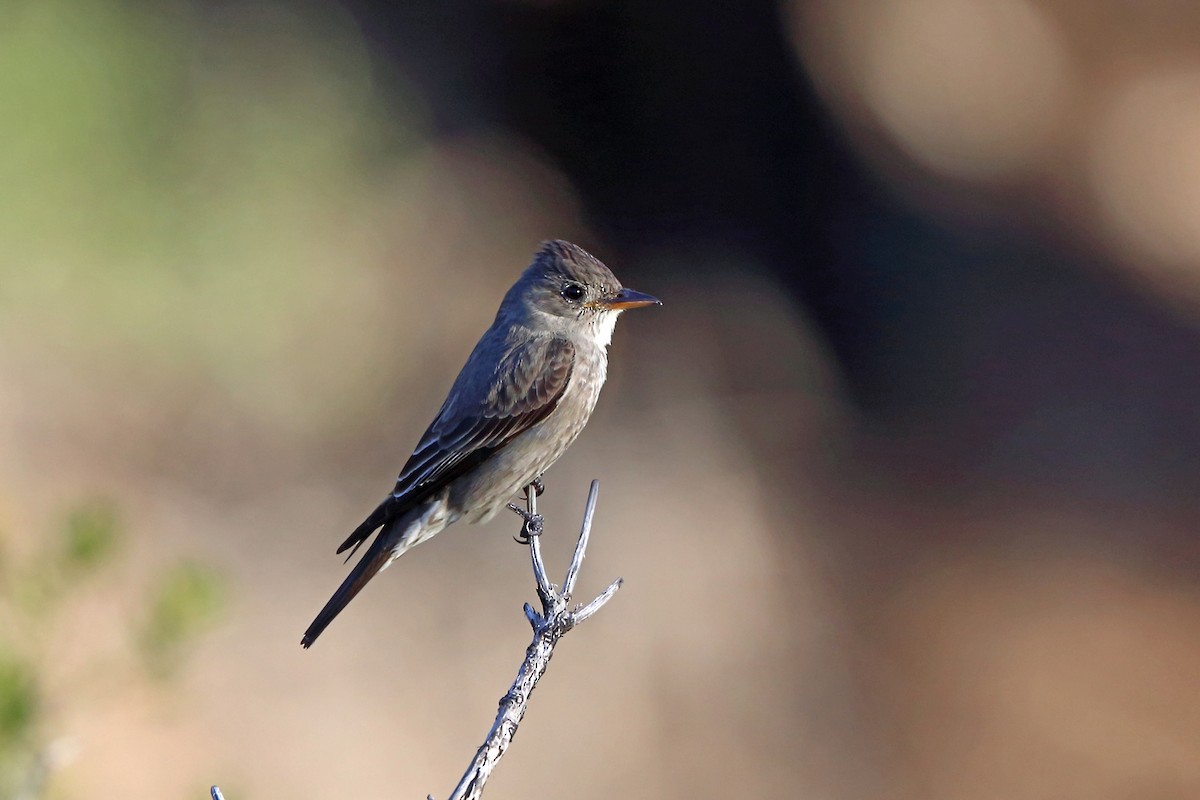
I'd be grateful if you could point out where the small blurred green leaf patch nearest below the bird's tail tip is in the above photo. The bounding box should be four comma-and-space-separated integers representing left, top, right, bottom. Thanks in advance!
138, 563, 227, 678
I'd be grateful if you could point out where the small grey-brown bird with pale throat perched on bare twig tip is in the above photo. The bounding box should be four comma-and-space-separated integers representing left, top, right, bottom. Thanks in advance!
300, 240, 662, 649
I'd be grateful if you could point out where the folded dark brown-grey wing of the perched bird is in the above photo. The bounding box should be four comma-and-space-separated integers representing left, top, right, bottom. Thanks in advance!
337, 337, 575, 555
